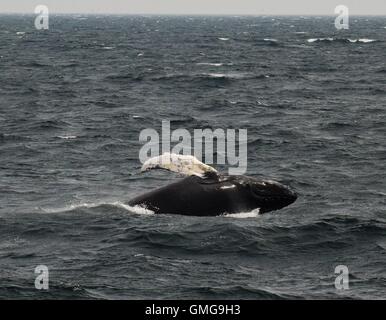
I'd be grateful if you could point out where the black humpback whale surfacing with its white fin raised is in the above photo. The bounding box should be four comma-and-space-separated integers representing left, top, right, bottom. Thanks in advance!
128, 153, 297, 216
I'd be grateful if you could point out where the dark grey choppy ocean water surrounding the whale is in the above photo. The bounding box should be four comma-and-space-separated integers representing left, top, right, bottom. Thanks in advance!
0, 15, 386, 299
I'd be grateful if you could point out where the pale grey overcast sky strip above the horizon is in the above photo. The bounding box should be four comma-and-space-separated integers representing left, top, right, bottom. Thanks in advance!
0, 0, 386, 16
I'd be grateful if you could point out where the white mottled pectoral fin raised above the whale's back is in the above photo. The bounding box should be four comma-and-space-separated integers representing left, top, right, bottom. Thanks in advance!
141, 152, 217, 178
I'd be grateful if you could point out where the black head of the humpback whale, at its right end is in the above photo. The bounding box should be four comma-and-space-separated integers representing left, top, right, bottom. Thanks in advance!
248, 179, 298, 213
